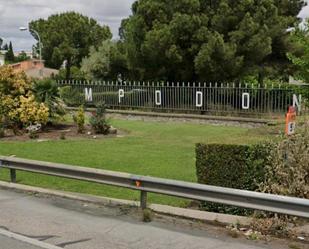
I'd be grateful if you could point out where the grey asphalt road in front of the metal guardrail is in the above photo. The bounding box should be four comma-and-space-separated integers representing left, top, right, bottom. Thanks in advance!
0, 189, 294, 249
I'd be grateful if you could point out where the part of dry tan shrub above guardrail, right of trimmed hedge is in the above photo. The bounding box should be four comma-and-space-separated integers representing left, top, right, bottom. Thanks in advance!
260, 123, 309, 199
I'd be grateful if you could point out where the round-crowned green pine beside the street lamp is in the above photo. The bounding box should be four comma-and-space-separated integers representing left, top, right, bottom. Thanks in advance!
29, 12, 112, 79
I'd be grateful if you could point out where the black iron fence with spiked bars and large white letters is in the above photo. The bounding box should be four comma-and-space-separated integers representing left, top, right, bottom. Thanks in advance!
57, 81, 309, 116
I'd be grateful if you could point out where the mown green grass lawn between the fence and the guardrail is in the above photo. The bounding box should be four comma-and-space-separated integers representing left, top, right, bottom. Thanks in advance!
0, 120, 276, 206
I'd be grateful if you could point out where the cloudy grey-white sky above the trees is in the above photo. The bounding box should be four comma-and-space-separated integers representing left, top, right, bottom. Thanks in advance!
0, 0, 309, 51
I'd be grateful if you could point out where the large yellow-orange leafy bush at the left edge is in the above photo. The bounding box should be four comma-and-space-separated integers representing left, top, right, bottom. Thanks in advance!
0, 66, 49, 129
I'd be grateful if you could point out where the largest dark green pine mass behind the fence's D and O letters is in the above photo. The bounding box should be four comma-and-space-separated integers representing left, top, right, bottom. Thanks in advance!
120, 0, 303, 81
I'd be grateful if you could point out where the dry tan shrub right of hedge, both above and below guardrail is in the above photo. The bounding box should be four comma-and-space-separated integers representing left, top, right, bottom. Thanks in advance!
251, 121, 309, 237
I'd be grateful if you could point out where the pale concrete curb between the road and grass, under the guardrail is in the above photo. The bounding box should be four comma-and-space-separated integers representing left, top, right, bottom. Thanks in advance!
0, 181, 252, 226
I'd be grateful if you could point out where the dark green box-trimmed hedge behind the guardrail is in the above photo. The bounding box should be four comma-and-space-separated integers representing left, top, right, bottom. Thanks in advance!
196, 144, 269, 215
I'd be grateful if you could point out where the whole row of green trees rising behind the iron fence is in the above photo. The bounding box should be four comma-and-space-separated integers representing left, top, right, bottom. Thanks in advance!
26, 0, 304, 82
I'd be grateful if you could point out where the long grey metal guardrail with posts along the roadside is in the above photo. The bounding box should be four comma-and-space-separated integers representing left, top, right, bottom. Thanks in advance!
0, 157, 309, 218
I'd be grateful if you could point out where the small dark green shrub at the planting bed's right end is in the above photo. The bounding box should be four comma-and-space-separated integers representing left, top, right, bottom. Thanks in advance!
89, 103, 110, 135
